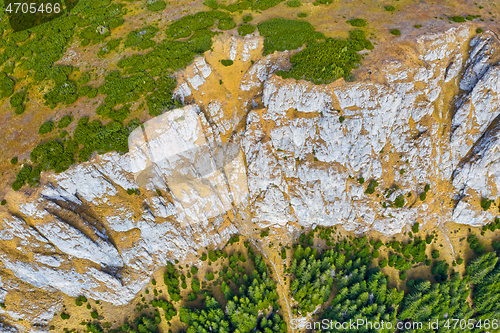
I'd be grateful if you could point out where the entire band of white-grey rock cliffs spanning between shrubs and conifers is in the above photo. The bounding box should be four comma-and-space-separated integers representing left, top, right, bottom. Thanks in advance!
0, 27, 500, 331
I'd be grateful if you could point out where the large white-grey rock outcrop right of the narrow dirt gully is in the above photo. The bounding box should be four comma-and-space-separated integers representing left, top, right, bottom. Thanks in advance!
244, 28, 500, 234
